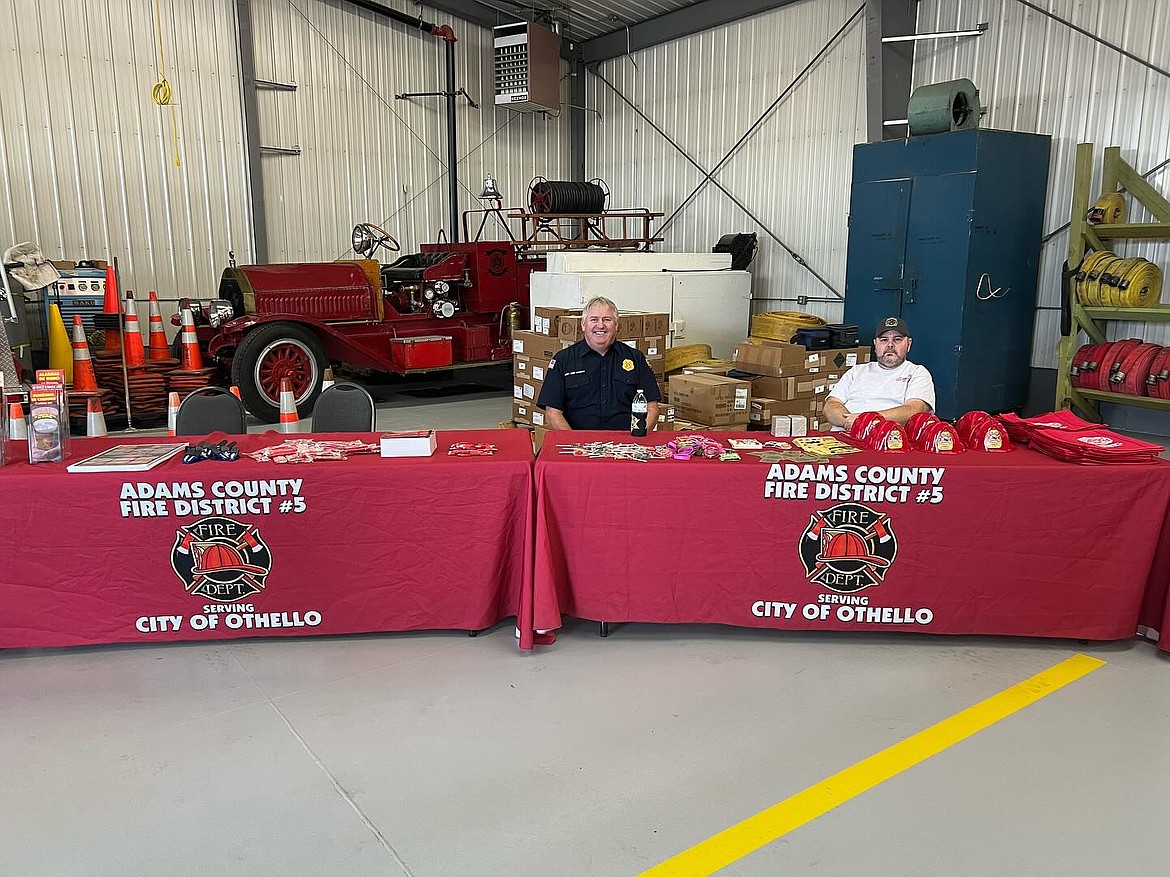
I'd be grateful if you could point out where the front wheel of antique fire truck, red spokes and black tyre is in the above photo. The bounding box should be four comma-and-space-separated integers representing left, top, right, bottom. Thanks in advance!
232, 323, 329, 423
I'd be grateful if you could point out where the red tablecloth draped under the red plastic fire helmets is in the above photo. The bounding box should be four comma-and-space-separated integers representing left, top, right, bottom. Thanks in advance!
530, 433, 1170, 648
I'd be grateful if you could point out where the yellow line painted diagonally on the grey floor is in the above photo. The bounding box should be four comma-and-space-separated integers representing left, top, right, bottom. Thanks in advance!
639, 655, 1104, 877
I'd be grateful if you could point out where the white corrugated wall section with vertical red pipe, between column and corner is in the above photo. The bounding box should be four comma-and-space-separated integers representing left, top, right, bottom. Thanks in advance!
253, 0, 569, 262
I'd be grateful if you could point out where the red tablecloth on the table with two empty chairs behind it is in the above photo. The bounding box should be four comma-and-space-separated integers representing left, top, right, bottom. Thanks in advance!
0, 429, 532, 648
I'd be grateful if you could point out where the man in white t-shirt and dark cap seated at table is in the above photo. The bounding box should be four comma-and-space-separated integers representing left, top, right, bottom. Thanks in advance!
825, 317, 935, 429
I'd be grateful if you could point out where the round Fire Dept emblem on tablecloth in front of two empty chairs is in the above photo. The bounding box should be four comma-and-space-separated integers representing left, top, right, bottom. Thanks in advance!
171, 518, 273, 603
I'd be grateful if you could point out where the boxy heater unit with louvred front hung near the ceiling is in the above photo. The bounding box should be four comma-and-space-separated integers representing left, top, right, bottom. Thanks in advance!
495, 22, 560, 112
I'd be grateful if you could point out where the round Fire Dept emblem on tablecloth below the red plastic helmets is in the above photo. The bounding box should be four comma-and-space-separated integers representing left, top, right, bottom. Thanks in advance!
800, 503, 897, 594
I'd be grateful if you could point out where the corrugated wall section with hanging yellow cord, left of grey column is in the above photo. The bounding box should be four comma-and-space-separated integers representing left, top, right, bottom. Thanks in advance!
0, 0, 250, 306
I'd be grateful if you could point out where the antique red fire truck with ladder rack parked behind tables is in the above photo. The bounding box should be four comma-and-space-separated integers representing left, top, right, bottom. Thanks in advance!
179, 184, 661, 423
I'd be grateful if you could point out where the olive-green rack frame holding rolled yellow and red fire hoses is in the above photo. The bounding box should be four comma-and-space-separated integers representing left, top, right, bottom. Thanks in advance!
1057, 143, 1170, 421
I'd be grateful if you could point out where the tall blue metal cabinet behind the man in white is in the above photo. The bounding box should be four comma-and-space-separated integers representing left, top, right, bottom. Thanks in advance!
845, 130, 1051, 419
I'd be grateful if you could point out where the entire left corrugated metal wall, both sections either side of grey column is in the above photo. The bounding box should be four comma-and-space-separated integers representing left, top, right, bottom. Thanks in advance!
0, 0, 569, 299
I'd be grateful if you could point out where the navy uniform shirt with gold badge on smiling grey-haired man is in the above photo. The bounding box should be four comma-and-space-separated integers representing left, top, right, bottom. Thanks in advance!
536, 339, 662, 429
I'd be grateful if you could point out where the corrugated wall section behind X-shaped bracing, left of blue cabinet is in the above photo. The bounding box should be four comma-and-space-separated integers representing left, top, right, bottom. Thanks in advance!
586, 0, 866, 319
